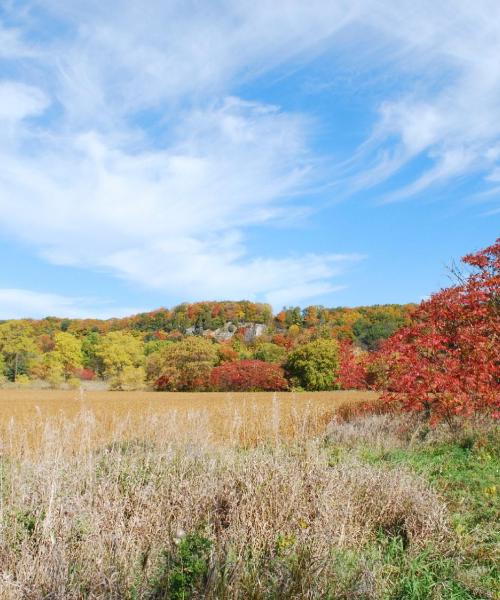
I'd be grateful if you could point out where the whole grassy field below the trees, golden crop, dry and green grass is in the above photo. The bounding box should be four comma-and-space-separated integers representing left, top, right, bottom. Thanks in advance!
0, 390, 500, 600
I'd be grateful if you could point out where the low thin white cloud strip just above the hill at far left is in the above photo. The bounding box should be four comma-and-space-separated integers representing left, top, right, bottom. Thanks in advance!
0, 288, 140, 320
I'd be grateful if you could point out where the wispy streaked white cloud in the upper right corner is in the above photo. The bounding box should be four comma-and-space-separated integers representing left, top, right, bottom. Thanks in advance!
354, 0, 500, 200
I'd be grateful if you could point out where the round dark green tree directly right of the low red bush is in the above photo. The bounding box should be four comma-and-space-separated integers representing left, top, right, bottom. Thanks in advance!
286, 339, 339, 391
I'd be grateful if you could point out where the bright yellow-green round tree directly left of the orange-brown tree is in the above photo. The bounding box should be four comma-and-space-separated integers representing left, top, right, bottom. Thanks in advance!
96, 331, 144, 378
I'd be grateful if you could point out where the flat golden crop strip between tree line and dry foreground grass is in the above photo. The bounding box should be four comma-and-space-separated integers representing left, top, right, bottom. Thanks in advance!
0, 389, 377, 452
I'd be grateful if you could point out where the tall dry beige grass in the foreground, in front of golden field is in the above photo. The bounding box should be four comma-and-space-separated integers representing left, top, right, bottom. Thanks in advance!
0, 398, 454, 600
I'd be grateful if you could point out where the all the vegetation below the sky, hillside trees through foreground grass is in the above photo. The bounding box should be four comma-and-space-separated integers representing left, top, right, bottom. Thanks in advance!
0, 240, 500, 600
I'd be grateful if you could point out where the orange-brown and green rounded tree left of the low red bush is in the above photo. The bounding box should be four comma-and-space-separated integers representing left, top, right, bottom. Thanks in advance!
155, 336, 218, 391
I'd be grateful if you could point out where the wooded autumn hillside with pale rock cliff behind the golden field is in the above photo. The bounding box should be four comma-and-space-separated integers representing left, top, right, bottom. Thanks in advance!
0, 302, 413, 391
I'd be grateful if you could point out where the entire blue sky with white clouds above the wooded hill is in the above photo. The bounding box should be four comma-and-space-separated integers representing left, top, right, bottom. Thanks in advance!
0, 0, 500, 319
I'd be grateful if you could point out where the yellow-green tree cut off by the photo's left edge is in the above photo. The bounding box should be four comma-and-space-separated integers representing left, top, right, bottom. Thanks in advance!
0, 321, 37, 381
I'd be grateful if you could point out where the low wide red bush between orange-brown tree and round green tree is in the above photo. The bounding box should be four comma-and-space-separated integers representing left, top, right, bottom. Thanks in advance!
210, 360, 288, 392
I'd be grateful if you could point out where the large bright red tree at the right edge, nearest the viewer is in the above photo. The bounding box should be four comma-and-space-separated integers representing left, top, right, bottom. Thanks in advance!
379, 239, 500, 422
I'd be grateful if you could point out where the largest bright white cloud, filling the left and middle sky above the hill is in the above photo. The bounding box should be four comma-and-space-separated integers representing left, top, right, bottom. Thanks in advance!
0, 98, 359, 302
